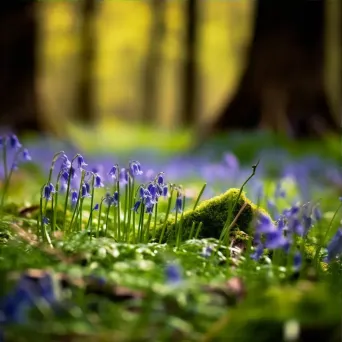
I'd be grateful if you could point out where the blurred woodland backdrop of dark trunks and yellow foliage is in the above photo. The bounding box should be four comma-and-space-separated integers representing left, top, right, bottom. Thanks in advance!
0, 0, 342, 149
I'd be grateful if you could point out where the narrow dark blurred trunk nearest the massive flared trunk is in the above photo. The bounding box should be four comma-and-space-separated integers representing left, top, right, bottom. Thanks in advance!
181, 0, 199, 126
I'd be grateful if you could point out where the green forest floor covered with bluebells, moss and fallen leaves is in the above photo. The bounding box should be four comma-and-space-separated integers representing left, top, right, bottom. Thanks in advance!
0, 132, 342, 342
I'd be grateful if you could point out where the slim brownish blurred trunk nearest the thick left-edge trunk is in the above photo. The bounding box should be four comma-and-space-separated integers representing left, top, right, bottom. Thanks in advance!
75, 0, 96, 124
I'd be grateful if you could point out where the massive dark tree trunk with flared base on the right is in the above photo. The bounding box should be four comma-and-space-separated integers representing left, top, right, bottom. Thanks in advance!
213, 0, 339, 138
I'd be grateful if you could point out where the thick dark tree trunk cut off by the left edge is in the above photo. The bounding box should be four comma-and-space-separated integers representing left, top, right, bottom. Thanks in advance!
0, 1, 42, 133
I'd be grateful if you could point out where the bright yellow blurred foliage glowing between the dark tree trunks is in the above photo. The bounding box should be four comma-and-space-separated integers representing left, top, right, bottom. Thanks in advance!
37, 0, 254, 130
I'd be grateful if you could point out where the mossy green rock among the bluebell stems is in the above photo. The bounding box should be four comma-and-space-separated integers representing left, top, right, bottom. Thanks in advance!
157, 188, 268, 242
